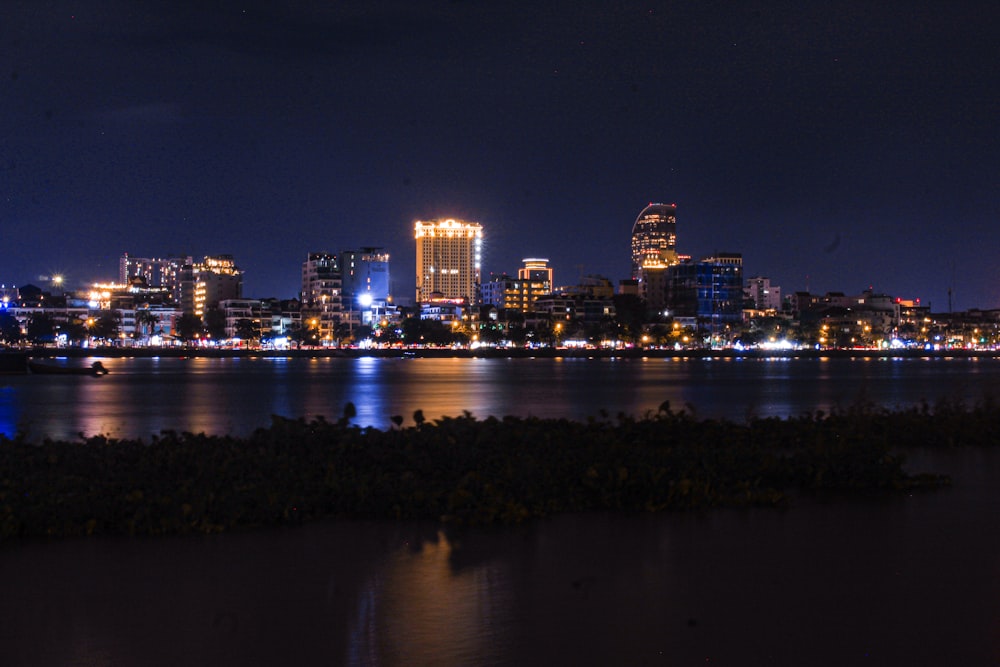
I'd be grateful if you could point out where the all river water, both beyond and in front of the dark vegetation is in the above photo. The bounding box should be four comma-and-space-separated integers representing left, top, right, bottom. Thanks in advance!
0, 359, 1000, 666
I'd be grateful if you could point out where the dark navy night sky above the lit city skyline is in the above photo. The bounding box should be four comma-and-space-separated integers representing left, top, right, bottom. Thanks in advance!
0, 0, 1000, 311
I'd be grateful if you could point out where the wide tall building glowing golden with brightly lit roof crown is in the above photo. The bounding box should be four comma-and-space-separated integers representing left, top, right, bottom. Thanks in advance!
413, 219, 483, 304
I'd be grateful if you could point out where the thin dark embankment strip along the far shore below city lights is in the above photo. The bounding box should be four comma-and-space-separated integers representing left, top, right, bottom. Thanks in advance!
13, 347, 1000, 359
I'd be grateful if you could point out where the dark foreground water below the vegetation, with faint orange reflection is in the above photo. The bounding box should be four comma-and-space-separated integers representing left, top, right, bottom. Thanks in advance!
0, 451, 1000, 666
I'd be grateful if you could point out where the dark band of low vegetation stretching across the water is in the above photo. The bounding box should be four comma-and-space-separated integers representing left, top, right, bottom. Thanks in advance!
0, 402, 984, 539
